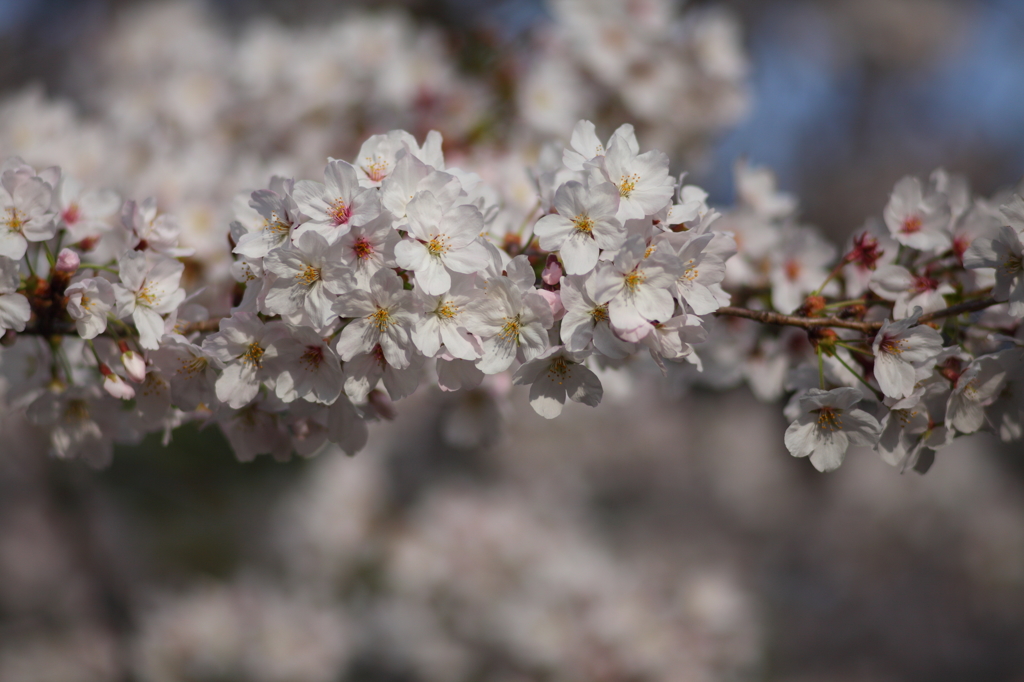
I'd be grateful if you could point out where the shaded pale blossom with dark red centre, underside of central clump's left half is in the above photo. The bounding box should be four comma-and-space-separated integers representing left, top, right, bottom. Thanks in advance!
274, 327, 343, 404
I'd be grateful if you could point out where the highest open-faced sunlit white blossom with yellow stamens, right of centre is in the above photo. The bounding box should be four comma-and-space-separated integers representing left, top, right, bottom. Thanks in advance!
590, 136, 675, 222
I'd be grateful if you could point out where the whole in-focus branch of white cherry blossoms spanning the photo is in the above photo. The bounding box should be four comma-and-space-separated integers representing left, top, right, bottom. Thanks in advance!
0, 116, 1024, 470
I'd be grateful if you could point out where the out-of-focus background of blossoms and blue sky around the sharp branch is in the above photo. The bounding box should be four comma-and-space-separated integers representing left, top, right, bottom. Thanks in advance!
0, 0, 1024, 682
